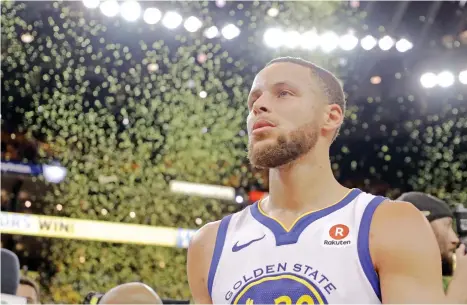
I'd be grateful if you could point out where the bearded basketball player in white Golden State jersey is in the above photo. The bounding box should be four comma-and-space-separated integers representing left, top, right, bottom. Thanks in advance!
187, 58, 447, 304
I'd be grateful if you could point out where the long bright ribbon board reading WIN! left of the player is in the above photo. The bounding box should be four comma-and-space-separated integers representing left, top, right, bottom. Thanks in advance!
0, 212, 196, 248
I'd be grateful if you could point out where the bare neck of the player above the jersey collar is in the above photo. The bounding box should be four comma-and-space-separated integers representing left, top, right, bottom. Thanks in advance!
268, 147, 348, 212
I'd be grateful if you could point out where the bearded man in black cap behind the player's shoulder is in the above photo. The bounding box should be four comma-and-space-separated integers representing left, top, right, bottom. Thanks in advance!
396, 192, 467, 304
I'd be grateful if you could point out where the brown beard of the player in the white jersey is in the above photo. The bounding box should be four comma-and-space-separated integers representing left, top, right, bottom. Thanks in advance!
248, 123, 318, 169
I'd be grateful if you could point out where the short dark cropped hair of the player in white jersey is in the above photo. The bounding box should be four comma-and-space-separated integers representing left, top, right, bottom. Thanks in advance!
266, 56, 347, 141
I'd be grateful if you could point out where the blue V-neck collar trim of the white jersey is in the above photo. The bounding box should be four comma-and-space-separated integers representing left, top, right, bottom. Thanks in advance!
250, 189, 362, 246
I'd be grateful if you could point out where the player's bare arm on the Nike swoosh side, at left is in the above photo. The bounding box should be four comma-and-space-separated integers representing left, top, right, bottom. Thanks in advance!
187, 221, 220, 304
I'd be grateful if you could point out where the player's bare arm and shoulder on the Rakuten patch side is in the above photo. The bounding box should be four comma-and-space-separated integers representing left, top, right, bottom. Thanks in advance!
370, 201, 447, 304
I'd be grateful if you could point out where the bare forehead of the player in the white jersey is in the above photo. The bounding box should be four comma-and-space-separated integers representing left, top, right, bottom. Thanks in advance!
251, 62, 312, 91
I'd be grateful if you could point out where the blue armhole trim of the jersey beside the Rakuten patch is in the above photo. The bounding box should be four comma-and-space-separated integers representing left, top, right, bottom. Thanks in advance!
357, 196, 387, 301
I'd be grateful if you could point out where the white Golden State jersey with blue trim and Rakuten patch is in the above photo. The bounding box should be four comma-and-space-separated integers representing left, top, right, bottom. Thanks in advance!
208, 189, 387, 304
